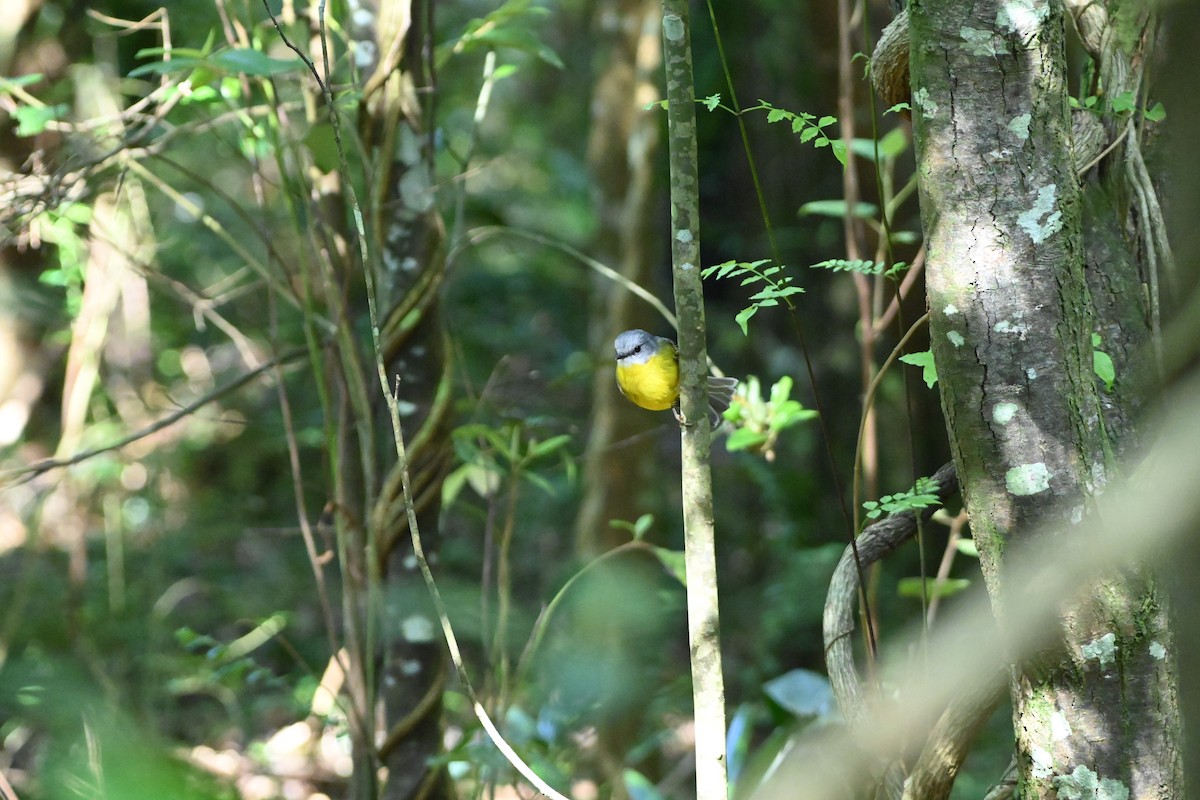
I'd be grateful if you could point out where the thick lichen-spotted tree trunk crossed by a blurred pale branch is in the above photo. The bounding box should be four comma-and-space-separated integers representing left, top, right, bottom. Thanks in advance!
910, 0, 1183, 798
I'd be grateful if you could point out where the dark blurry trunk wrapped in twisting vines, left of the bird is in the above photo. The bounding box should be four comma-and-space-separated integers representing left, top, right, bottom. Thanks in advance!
350, 0, 451, 800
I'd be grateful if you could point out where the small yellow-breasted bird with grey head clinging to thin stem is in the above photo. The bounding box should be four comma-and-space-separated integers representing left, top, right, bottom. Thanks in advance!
616, 329, 738, 431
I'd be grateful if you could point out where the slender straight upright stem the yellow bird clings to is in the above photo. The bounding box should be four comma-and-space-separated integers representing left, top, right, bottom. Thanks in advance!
662, 0, 728, 800
